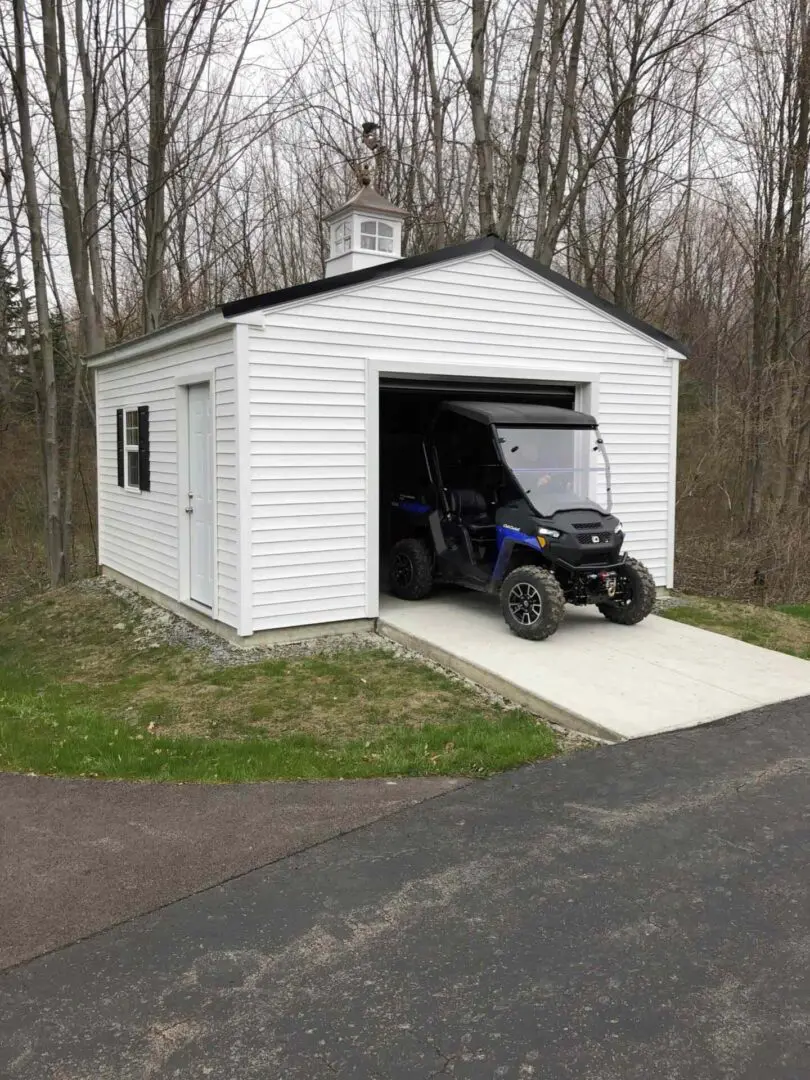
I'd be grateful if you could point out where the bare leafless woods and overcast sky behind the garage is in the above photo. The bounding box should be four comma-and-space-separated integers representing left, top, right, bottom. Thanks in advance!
0, 0, 810, 602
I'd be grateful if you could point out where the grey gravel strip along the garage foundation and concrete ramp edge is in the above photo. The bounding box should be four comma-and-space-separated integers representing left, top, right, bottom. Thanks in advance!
77, 577, 599, 752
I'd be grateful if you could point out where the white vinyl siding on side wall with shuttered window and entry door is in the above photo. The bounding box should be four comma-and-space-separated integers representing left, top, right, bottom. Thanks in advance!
96, 326, 240, 626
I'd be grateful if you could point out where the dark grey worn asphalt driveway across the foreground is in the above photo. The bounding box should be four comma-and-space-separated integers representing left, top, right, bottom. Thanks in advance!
0, 699, 810, 1080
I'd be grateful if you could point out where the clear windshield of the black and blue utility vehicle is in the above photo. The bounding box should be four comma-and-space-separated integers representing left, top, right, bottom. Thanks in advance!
496, 428, 610, 517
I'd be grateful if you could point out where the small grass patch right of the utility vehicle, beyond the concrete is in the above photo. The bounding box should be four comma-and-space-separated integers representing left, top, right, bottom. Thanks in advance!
661, 596, 810, 660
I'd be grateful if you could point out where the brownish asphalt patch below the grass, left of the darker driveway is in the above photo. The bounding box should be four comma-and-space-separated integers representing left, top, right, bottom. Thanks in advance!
0, 773, 463, 972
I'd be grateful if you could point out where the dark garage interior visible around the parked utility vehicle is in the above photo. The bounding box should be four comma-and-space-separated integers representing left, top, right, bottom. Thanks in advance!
379, 376, 576, 593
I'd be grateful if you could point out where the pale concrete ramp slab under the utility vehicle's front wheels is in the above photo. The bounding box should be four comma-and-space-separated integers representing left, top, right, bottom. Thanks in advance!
378, 591, 810, 742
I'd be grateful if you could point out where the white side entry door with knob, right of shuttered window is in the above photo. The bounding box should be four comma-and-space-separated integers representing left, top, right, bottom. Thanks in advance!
186, 382, 214, 607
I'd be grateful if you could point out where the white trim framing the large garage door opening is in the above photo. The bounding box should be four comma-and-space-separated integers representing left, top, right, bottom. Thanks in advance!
365, 355, 599, 619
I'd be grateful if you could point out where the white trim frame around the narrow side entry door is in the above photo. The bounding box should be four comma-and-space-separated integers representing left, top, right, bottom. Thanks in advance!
175, 367, 219, 619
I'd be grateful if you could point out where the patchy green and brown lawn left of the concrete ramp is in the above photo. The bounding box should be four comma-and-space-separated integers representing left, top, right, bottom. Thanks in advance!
0, 582, 558, 782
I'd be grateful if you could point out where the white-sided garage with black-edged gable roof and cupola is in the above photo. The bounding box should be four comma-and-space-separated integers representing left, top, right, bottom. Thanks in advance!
91, 180, 685, 637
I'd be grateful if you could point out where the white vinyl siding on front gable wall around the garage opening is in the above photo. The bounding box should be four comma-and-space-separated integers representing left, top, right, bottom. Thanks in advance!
249, 252, 673, 630
